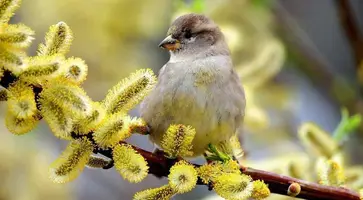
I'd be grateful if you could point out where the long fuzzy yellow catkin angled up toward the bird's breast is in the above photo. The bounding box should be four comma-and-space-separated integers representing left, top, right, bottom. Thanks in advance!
103, 69, 156, 114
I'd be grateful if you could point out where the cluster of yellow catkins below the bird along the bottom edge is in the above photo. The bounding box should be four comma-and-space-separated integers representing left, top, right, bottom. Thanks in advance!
134, 160, 270, 200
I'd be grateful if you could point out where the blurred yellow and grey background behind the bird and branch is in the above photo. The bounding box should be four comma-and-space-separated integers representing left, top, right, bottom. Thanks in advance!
0, 0, 363, 200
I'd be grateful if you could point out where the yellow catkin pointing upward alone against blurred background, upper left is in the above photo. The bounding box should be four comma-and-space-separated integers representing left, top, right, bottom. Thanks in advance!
38, 22, 73, 55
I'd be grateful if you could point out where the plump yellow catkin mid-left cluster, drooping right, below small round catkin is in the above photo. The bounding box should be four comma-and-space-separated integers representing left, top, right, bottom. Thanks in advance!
40, 78, 92, 117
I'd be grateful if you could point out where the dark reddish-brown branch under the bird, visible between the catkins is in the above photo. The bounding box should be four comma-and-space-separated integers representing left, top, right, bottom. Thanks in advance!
0, 69, 360, 200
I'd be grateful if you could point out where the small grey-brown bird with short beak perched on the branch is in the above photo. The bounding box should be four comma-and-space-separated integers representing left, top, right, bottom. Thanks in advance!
140, 13, 246, 161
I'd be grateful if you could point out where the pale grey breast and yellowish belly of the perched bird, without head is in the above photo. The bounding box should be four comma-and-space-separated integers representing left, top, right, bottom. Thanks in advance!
141, 57, 242, 154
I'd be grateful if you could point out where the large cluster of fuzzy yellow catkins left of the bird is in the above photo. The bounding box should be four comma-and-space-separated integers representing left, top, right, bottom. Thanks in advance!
0, 0, 156, 186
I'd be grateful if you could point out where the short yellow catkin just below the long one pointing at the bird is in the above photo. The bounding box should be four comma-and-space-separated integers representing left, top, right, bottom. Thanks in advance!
93, 114, 131, 148
